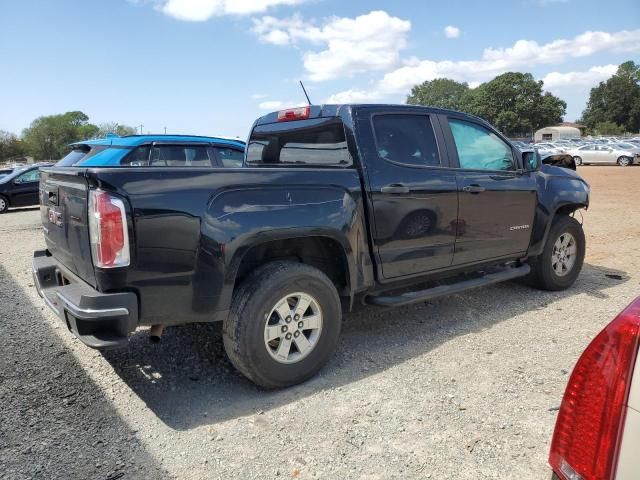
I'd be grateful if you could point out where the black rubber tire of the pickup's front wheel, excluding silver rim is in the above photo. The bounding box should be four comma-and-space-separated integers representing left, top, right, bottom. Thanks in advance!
526, 215, 586, 291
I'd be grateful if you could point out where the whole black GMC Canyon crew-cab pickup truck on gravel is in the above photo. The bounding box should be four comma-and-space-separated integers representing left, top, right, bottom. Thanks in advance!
33, 105, 589, 388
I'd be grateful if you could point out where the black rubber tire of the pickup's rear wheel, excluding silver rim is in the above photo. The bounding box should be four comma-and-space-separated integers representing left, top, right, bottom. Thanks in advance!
222, 261, 342, 389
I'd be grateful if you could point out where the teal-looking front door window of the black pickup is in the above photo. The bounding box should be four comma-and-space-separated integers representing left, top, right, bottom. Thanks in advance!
449, 119, 514, 170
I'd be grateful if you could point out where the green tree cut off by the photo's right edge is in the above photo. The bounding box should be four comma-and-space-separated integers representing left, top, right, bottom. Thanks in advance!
582, 61, 640, 132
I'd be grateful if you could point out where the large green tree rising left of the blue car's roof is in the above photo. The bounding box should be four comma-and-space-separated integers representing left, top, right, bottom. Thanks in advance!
22, 111, 98, 160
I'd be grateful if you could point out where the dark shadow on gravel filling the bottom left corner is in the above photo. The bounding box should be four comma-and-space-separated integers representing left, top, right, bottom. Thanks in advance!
0, 265, 171, 480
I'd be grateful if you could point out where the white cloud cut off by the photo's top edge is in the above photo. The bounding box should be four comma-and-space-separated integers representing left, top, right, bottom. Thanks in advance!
148, 0, 308, 22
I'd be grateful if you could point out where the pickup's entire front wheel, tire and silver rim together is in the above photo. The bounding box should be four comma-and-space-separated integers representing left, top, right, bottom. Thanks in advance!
528, 215, 586, 291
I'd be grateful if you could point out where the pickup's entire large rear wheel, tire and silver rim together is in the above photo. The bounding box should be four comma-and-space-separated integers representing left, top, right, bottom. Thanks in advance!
222, 261, 342, 389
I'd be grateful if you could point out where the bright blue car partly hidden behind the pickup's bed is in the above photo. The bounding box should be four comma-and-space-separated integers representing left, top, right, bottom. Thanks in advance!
56, 135, 244, 167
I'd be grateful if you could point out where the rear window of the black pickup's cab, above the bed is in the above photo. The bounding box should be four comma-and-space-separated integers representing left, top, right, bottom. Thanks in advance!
247, 118, 352, 167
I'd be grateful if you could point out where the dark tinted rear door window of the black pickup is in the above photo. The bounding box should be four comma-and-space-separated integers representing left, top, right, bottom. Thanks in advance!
373, 114, 440, 167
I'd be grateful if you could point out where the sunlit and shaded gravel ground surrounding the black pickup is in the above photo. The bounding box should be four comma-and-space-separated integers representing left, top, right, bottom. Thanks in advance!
0, 167, 640, 480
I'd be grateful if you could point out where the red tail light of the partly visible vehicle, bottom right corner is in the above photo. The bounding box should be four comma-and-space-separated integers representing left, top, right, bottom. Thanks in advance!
549, 298, 640, 480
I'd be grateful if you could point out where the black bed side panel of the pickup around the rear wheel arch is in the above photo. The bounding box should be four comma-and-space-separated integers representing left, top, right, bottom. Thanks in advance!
90, 168, 370, 324
